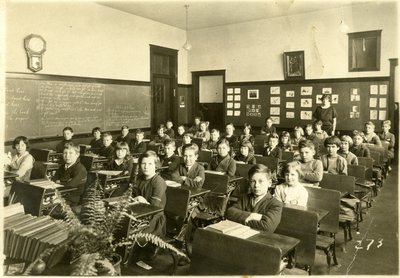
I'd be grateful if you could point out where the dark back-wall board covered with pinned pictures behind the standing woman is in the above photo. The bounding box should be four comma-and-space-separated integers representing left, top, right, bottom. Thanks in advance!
224, 77, 390, 131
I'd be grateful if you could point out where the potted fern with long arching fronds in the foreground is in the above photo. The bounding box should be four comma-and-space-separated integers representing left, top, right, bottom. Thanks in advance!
25, 179, 186, 276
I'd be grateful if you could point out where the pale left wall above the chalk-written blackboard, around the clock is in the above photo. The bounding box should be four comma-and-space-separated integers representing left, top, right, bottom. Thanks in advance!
5, 1, 188, 84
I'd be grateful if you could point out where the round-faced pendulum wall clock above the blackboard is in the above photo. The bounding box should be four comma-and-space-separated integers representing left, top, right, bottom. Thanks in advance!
24, 34, 46, 72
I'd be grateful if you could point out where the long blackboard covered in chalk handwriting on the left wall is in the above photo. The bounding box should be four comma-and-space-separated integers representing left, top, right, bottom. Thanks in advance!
5, 74, 151, 140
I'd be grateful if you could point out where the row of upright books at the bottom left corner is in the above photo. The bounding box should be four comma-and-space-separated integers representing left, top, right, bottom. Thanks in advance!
3, 203, 69, 268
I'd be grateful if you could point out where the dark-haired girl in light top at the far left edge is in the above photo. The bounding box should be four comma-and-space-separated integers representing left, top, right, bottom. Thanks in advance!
5, 136, 35, 182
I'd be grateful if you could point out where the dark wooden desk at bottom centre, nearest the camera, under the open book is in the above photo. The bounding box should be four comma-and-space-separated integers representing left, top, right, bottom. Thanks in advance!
191, 228, 300, 275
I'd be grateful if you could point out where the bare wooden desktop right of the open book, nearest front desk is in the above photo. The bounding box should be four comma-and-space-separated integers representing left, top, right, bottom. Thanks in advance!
247, 231, 300, 257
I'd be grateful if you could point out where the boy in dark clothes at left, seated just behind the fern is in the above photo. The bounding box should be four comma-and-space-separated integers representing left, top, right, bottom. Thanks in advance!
53, 144, 87, 207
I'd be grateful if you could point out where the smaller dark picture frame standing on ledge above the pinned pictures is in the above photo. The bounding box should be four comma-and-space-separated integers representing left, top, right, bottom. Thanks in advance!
283, 51, 305, 80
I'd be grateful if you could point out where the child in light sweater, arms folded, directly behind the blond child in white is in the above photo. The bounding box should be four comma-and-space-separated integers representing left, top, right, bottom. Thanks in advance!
299, 140, 324, 186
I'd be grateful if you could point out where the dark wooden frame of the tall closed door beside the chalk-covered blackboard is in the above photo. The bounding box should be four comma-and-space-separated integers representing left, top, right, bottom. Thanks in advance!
150, 44, 179, 132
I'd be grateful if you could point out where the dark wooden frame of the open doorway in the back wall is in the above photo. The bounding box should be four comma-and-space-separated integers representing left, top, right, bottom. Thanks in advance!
190, 69, 226, 126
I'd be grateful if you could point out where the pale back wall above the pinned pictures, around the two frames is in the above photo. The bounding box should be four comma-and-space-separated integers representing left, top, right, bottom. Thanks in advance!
188, 2, 398, 87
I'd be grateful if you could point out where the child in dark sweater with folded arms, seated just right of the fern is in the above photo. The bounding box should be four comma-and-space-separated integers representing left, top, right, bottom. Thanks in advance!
132, 151, 167, 237
